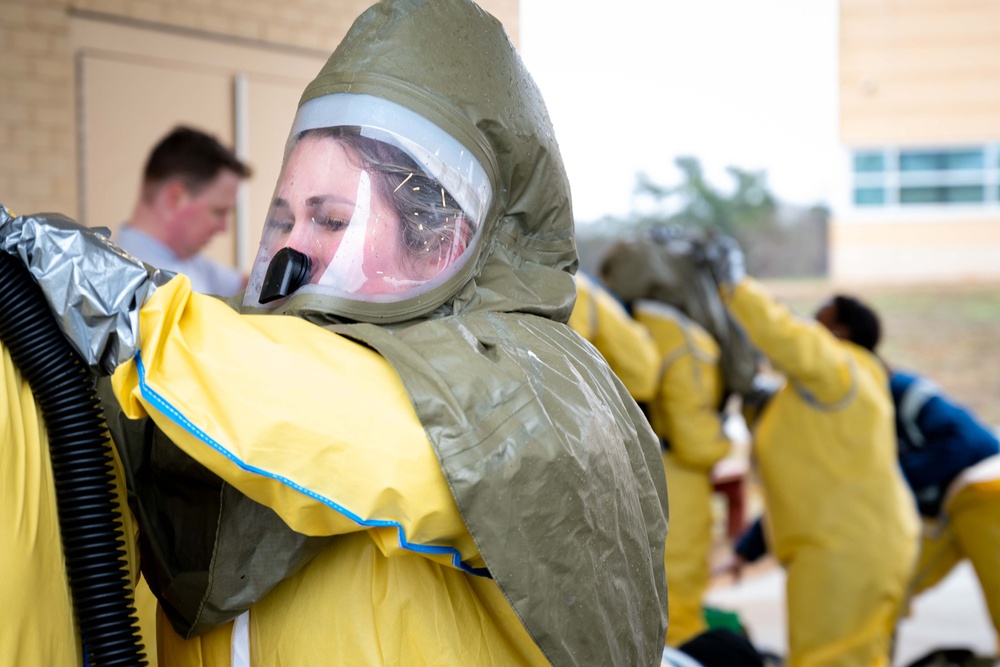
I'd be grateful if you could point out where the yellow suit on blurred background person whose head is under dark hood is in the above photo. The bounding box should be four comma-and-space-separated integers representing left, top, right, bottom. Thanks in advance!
633, 301, 730, 646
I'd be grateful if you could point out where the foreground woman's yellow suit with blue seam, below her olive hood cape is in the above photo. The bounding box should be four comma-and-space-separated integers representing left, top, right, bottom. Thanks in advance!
108, 279, 547, 665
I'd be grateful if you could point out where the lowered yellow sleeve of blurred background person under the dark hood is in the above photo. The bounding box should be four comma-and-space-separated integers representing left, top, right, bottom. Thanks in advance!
636, 307, 731, 473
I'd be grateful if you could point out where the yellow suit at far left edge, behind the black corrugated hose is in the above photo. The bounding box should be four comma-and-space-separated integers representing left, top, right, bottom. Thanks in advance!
0, 344, 150, 667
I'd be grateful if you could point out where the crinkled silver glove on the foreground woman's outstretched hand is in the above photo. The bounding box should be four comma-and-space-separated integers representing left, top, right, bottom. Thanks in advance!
0, 205, 173, 375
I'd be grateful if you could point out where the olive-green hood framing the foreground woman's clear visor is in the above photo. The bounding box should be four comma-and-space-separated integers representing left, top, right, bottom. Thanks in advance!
244, 1, 577, 323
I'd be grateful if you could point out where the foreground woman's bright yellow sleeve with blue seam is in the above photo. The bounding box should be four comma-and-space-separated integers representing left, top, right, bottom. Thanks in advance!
112, 276, 482, 567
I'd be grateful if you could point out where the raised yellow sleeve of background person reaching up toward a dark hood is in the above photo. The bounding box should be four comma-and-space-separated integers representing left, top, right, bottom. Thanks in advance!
722, 278, 857, 406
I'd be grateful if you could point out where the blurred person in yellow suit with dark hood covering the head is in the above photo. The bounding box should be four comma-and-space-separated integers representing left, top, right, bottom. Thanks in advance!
601, 240, 744, 647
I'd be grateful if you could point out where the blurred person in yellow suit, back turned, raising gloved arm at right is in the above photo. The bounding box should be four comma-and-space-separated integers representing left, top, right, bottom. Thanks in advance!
709, 237, 919, 667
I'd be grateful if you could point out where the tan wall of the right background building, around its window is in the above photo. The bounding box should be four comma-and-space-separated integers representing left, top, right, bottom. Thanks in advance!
830, 0, 1000, 281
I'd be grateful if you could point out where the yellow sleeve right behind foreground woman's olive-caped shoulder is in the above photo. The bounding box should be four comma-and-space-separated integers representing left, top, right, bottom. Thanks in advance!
568, 272, 659, 403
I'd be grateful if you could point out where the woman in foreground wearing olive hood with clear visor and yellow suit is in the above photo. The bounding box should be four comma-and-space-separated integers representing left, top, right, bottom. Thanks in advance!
0, 0, 666, 666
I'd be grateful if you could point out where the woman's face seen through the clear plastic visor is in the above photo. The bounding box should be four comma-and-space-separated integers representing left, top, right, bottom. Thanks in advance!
265, 136, 412, 294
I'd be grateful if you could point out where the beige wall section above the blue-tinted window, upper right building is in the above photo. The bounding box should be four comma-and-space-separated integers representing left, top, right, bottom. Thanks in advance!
840, 0, 1000, 145
